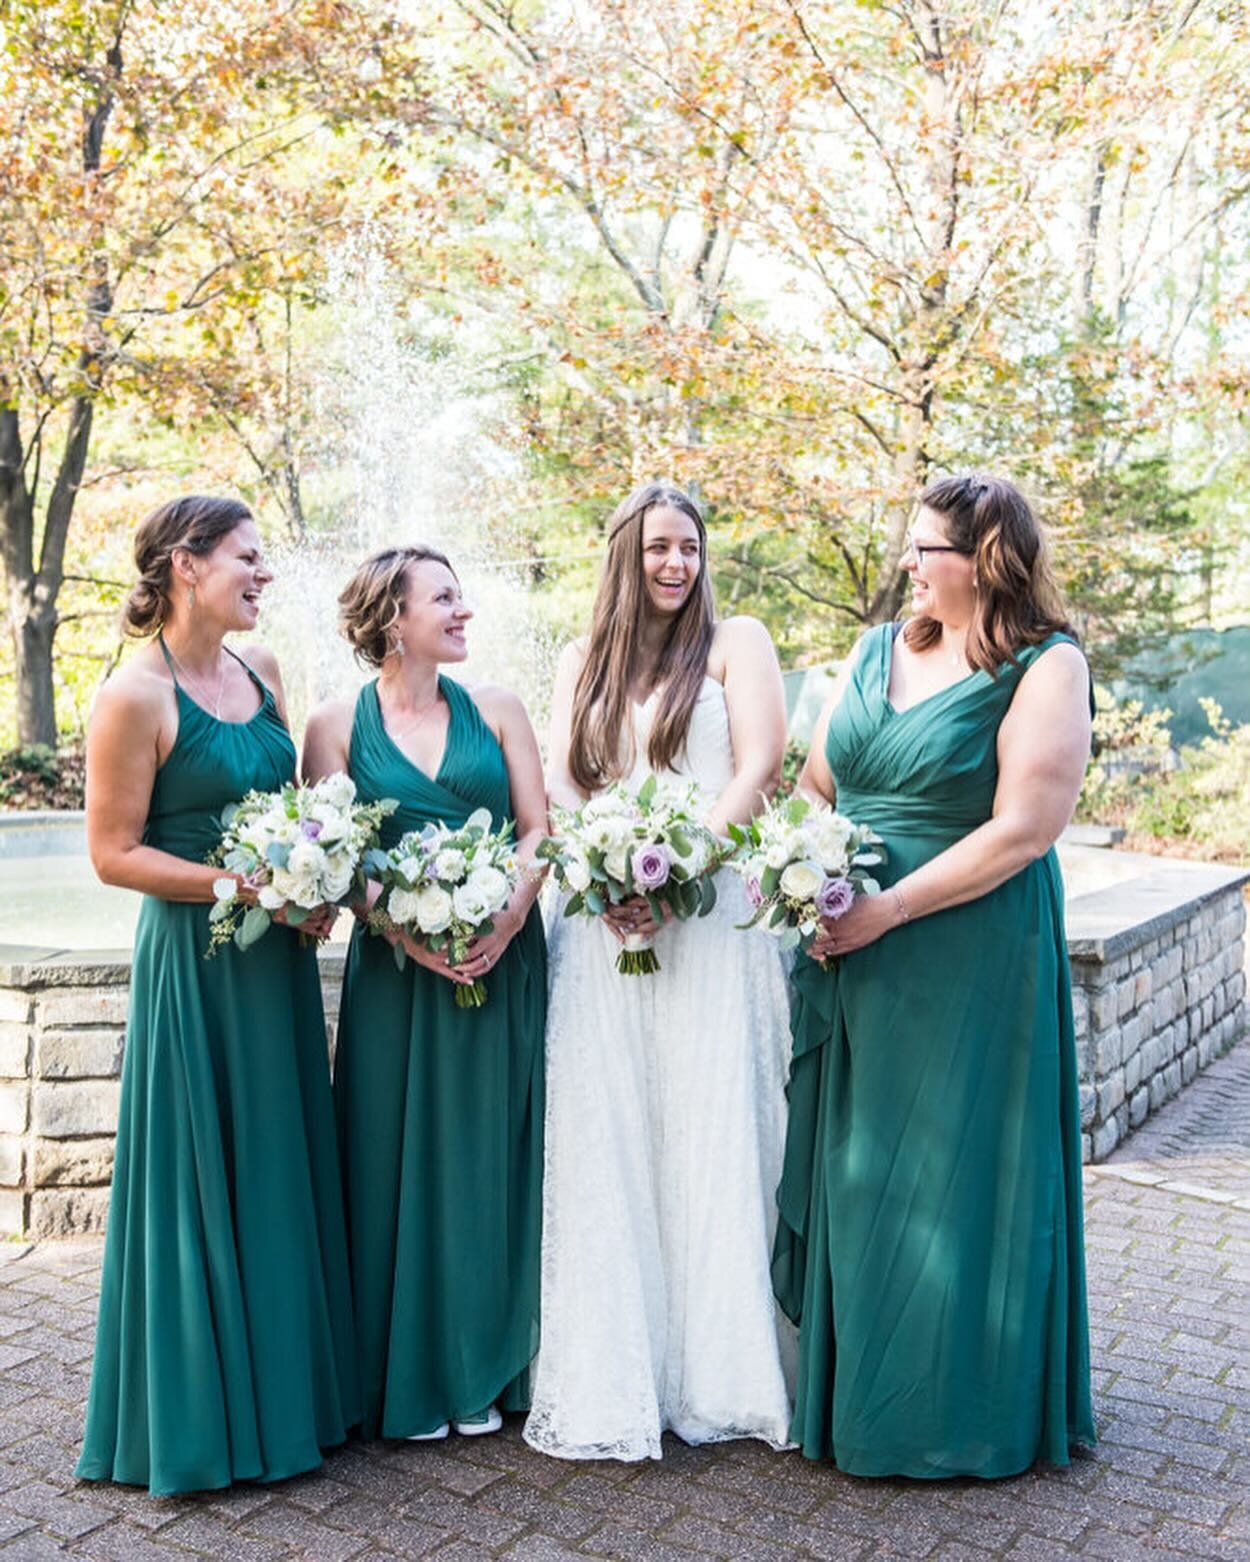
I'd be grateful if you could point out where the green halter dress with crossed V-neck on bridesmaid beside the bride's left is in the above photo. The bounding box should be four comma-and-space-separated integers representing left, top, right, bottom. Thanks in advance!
334, 678, 547, 1437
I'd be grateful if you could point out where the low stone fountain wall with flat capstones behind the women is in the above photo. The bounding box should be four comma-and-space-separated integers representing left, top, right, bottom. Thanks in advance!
0, 848, 1250, 1237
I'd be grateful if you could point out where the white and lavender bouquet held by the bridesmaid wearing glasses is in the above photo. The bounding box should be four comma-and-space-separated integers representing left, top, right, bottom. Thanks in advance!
730, 797, 886, 950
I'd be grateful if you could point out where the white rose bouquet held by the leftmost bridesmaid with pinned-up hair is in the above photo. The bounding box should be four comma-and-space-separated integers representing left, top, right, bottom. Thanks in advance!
206, 772, 398, 954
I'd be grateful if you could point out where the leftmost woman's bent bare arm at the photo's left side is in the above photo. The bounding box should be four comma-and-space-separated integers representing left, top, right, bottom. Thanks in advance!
86, 667, 222, 903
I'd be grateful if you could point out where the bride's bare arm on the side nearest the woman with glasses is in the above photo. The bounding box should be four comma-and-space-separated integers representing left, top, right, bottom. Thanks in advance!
708, 619, 786, 836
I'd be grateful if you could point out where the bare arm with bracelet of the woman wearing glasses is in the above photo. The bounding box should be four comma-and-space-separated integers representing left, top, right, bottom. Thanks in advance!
813, 644, 1091, 958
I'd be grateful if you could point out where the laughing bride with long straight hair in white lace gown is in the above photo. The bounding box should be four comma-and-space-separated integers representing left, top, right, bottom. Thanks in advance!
525, 483, 789, 1459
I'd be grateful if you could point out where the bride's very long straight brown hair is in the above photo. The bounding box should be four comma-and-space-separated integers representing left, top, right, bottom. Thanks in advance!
569, 483, 716, 792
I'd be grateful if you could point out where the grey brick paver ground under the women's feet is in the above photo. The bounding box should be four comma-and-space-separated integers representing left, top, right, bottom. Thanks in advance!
0, 1042, 1250, 1562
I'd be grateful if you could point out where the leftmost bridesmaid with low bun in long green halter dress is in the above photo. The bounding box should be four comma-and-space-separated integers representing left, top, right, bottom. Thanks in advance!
78, 497, 359, 1495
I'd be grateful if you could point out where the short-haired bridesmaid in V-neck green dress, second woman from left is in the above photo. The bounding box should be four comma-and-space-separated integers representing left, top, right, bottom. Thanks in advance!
305, 548, 547, 1439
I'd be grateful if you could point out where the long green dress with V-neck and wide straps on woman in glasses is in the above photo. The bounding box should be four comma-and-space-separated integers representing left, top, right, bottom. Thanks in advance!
773, 625, 1094, 1478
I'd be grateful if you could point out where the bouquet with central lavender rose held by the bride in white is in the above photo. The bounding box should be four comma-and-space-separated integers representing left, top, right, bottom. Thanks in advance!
538, 776, 720, 976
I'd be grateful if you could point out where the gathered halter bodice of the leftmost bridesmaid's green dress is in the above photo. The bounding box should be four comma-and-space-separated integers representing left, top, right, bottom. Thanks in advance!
144, 647, 295, 862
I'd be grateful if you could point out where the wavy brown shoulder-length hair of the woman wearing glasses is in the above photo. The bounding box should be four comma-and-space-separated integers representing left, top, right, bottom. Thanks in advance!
903, 475, 1077, 673
